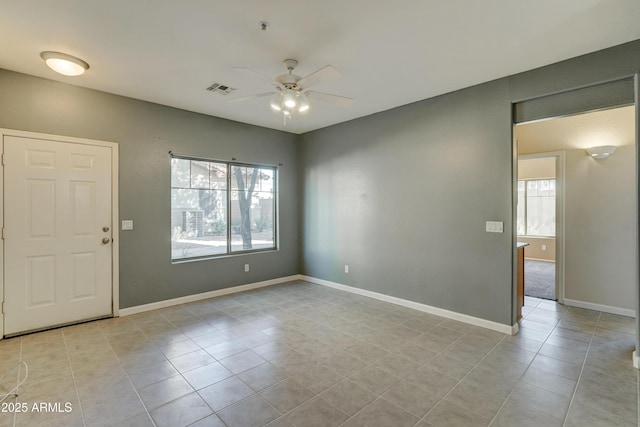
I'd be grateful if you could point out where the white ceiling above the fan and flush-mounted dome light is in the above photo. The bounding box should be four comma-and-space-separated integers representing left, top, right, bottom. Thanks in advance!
0, 0, 640, 133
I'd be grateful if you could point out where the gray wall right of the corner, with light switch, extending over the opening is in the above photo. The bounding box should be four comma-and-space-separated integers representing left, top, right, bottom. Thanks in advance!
301, 41, 640, 324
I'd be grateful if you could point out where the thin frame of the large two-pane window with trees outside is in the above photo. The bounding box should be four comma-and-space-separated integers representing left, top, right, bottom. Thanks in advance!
169, 152, 280, 264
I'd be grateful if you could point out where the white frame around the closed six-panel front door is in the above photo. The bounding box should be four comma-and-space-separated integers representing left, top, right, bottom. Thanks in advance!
0, 128, 120, 340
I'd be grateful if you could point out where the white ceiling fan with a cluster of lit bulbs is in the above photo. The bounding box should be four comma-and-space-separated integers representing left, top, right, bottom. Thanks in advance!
229, 59, 353, 125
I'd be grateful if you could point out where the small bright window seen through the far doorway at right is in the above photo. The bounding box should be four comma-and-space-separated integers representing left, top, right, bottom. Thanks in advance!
517, 179, 556, 237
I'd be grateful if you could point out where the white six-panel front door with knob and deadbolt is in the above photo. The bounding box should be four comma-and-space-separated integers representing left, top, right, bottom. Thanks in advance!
3, 135, 113, 335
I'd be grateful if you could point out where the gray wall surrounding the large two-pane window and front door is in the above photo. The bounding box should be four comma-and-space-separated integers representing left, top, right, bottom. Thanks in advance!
0, 70, 299, 308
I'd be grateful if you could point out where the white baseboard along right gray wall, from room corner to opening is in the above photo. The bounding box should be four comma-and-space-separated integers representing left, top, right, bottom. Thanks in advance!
300, 276, 518, 335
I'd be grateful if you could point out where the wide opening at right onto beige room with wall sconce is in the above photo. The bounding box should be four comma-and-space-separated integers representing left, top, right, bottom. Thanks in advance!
514, 105, 637, 316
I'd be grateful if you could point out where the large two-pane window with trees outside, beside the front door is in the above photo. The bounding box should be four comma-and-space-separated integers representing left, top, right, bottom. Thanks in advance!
171, 156, 277, 261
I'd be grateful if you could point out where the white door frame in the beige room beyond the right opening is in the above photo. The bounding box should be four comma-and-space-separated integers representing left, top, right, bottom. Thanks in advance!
515, 151, 565, 304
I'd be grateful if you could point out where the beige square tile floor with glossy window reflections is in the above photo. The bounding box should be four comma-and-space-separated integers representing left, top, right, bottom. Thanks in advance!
0, 282, 638, 427
